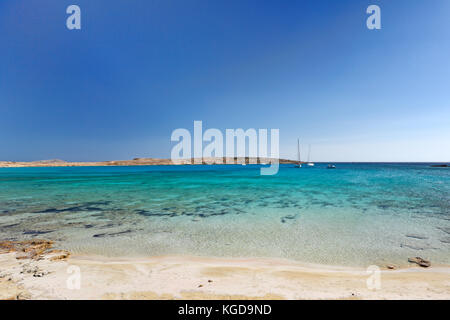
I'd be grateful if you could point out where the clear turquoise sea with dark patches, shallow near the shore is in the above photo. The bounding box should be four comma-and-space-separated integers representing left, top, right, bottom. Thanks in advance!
0, 163, 450, 266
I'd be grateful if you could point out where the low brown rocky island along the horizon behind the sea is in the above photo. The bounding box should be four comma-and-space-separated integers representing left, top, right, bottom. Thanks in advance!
0, 157, 298, 168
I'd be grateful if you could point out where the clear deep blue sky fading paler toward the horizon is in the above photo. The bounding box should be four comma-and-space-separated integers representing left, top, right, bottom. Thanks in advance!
0, 0, 450, 161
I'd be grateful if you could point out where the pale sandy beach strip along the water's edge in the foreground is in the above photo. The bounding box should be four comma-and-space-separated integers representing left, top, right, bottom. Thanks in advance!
0, 241, 450, 300
